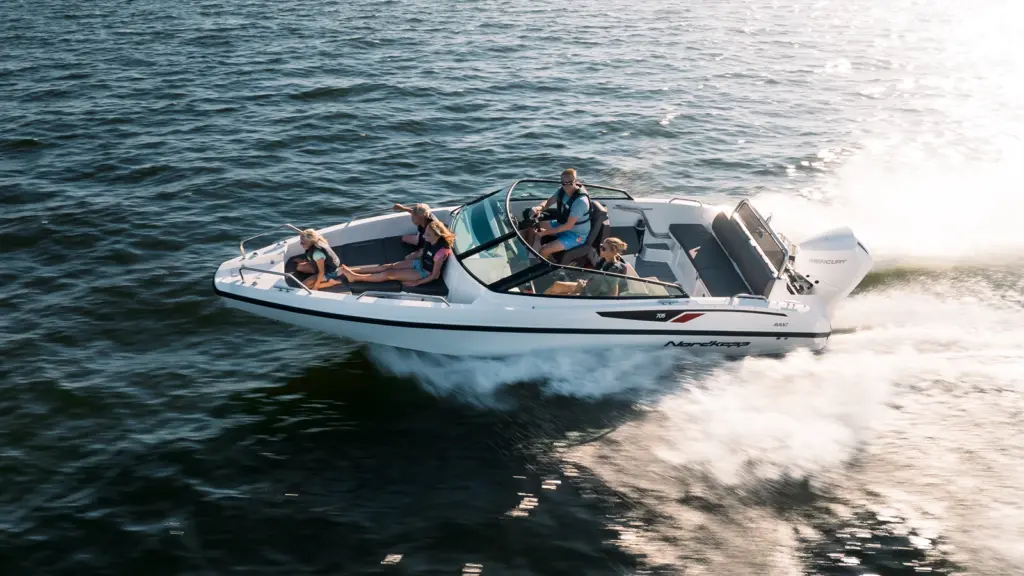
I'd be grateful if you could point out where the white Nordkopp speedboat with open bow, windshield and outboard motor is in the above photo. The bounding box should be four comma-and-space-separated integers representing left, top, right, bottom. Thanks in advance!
213, 178, 872, 356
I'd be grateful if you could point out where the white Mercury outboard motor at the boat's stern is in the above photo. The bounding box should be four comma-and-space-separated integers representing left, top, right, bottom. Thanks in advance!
792, 227, 873, 311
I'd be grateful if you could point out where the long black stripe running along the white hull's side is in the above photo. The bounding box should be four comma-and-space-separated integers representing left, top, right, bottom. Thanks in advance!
213, 285, 830, 338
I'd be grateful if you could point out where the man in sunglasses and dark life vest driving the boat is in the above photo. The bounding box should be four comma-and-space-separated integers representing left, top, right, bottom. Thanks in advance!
525, 168, 591, 259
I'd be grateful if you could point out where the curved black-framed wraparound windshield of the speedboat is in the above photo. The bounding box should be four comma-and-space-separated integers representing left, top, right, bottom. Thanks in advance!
452, 178, 689, 300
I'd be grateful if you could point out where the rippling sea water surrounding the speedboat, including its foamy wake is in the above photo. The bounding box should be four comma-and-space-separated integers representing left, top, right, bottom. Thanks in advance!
0, 0, 1024, 575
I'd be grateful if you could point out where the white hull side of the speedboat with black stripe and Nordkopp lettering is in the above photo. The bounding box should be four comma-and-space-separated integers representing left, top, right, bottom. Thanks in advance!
218, 278, 830, 357
